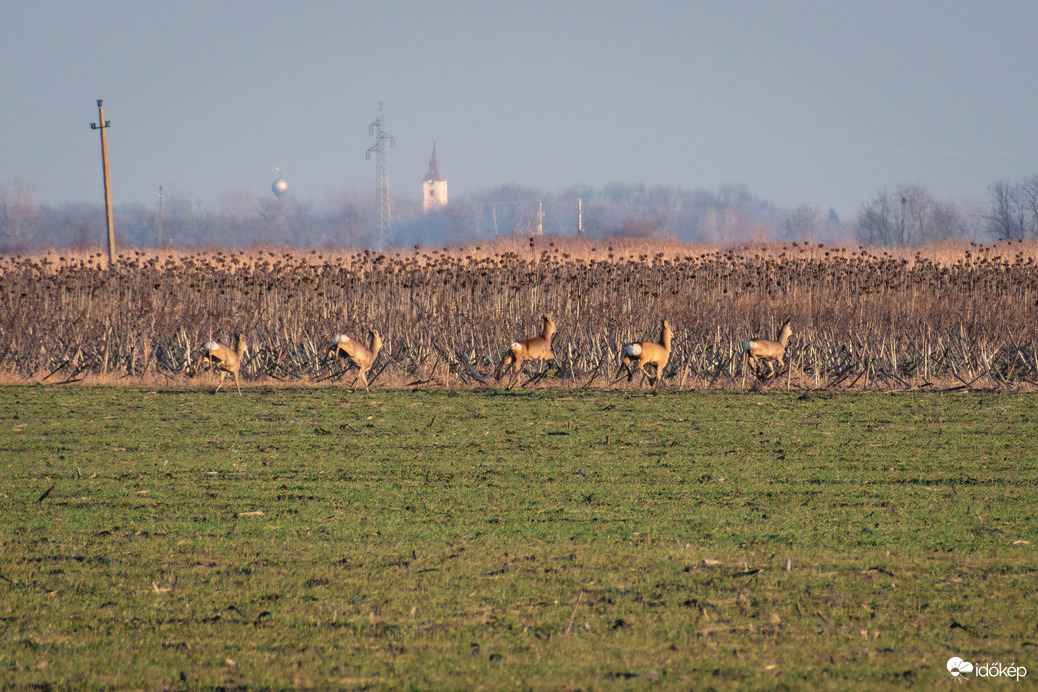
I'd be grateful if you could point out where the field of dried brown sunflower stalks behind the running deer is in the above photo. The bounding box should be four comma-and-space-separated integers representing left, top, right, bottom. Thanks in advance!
0, 238, 1038, 389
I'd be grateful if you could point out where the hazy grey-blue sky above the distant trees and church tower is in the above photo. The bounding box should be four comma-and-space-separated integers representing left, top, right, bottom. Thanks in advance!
0, 0, 1038, 217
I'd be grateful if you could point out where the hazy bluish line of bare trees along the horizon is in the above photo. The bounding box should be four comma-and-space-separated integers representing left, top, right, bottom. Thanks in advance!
0, 175, 1038, 253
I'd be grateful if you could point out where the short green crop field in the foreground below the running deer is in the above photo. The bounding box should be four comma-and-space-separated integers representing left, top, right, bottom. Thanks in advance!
0, 387, 1038, 689
